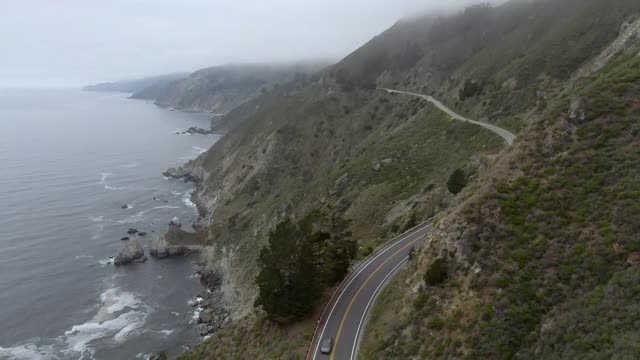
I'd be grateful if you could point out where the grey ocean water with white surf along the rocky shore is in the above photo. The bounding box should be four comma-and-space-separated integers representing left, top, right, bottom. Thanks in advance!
0, 88, 218, 359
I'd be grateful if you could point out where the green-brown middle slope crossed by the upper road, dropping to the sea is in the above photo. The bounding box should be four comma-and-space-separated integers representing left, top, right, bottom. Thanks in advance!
175, 0, 638, 358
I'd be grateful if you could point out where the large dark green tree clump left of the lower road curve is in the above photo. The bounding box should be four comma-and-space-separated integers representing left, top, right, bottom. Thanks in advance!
256, 211, 357, 324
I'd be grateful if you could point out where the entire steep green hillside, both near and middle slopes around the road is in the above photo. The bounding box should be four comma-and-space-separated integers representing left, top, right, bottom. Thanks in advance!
169, 0, 640, 359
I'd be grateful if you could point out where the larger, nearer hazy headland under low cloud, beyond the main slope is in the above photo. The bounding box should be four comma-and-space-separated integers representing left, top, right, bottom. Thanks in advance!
132, 62, 327, 114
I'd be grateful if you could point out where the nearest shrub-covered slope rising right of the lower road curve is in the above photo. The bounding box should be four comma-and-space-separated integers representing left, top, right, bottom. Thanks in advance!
361, 1, 640, 359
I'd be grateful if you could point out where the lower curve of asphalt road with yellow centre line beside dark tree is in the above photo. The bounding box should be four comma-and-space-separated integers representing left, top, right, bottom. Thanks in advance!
309, 222, 431, 360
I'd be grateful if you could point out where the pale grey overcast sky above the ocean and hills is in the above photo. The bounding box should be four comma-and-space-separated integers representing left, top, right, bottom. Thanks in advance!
0, 0, 477, 85
